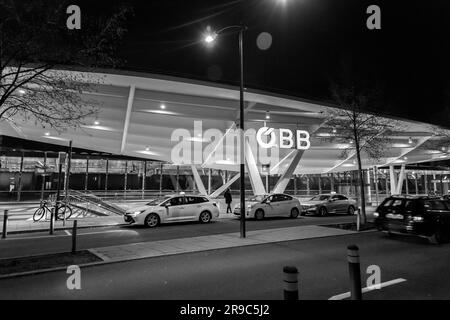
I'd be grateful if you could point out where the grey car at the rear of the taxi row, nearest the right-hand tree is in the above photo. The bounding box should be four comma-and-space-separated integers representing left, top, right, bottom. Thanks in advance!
302, 193, 356, 216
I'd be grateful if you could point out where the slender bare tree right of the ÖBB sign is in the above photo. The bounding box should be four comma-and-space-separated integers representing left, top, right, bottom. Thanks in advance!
324, 85, 402, 223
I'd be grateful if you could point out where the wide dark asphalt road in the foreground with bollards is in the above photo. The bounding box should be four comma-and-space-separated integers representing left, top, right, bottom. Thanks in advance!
0, 232, 450, 300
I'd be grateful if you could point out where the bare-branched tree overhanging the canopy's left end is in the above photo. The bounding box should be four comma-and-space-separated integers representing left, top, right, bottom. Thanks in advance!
0, 0, 132, 131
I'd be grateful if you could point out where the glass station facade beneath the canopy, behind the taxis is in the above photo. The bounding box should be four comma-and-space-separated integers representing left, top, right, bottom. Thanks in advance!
0, 153, 450, 202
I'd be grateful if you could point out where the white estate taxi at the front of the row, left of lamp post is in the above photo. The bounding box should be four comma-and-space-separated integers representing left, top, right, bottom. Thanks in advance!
124, 195, 219, 228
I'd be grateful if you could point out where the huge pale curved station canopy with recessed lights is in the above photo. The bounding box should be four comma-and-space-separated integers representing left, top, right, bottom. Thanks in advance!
0, 71, 450, 174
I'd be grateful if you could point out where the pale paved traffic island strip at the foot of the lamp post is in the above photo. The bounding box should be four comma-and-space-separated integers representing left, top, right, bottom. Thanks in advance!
89, 226, 357, 262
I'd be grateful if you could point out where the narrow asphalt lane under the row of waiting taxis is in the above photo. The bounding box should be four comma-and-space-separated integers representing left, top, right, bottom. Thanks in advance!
0, 215, 356, 258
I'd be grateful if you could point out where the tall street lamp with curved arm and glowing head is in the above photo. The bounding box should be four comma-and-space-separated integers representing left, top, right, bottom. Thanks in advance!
204, 24, 247, 238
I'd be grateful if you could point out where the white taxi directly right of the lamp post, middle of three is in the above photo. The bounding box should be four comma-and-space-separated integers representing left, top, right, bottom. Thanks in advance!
233, 193, 301, 220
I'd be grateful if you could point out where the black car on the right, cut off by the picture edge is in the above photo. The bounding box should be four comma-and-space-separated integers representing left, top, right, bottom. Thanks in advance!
374, 196, 450, 243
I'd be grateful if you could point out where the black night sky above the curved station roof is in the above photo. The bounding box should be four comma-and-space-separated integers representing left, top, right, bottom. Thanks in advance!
88, 0, 450, 127
